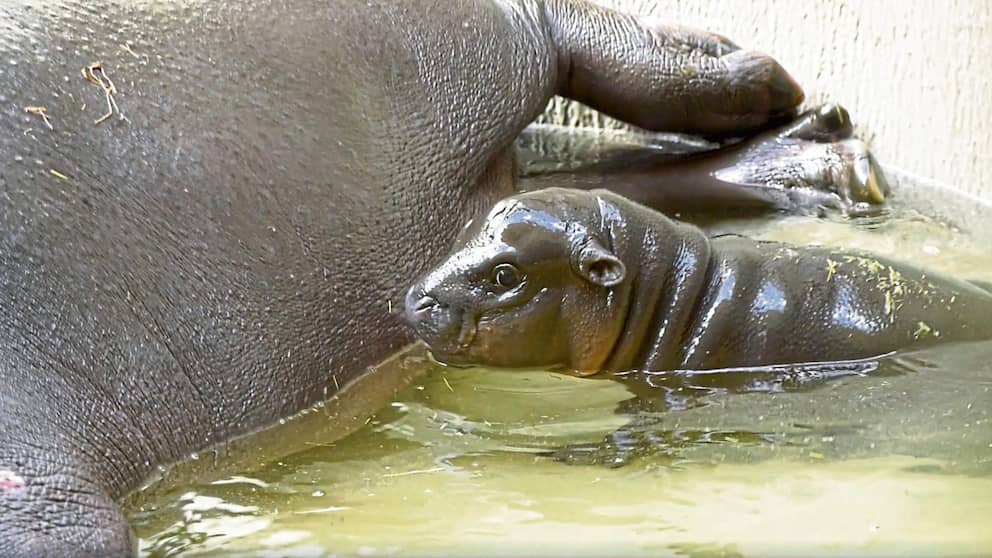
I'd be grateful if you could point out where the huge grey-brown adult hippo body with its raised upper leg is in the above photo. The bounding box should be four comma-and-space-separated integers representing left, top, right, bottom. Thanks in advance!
0, 0, 802, 556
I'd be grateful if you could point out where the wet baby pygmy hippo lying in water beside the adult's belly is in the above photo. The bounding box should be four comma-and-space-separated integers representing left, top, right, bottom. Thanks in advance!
406, 188, 992, 374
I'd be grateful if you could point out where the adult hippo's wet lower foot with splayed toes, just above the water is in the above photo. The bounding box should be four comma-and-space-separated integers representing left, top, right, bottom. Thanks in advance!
714, 104, 890, 215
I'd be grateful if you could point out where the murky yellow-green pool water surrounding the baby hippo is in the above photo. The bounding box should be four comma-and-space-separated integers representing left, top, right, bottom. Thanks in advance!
130, 195, 992, 556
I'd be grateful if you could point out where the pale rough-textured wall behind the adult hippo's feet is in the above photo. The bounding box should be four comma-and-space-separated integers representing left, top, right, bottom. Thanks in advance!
548, 0, 992, 199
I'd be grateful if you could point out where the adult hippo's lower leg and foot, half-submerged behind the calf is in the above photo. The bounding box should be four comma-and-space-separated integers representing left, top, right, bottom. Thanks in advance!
518, 104, 889, 218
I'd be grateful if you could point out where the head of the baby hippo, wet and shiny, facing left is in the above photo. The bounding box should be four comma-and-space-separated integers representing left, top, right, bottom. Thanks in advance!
405, 188, 629, 373
